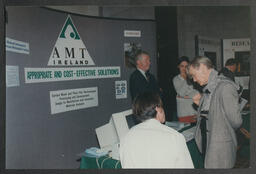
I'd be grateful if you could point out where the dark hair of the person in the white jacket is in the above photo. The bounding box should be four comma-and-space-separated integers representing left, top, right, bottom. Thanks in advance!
132, 92, 163, 121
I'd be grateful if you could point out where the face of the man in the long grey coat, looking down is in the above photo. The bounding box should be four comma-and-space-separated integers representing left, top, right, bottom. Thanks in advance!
189, 64, 210, 86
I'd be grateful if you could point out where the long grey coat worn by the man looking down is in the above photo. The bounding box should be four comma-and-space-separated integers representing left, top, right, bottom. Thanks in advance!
195, 70, 242, 168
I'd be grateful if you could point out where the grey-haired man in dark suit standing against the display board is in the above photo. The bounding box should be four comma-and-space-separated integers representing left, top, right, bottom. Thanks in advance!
129, 51, 160, 100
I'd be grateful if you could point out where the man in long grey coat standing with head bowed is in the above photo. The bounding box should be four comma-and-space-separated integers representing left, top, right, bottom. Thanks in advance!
187, 57, 242, 168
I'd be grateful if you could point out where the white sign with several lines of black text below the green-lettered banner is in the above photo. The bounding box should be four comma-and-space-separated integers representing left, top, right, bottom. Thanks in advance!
50, 87, 98, 114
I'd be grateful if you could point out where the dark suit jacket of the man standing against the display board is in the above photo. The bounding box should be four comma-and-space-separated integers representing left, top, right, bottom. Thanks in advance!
129, 69, 160, 100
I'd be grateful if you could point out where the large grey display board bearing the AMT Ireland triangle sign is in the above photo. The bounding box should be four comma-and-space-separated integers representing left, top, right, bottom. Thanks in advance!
6, 7, 157, 169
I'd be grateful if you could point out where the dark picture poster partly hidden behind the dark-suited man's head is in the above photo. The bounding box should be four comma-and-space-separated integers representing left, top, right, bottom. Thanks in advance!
124, 42, 141, 68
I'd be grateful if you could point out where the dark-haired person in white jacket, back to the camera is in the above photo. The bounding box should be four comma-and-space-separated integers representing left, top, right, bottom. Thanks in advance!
119, 92, 194, 168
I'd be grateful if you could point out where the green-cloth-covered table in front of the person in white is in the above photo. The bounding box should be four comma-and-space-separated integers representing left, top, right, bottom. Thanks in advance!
80, 125, 203, 169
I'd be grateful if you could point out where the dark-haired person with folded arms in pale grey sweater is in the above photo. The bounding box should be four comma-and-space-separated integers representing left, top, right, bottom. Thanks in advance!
172, 56, 201, 123
